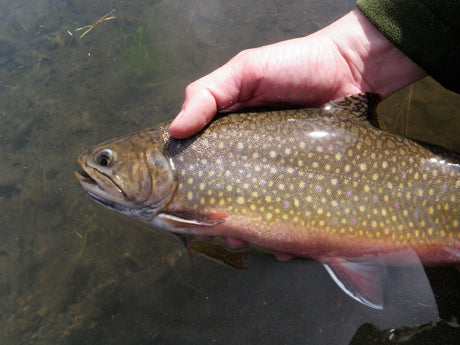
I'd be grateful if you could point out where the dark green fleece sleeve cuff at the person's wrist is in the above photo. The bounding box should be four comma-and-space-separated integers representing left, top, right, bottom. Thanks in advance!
357, 0, 460, 93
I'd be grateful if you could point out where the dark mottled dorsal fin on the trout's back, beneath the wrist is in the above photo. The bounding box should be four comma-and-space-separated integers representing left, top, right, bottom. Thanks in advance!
321, 92, 381, 128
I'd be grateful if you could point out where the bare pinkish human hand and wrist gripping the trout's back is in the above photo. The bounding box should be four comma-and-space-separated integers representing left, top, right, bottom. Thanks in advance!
169, 10, 426, 139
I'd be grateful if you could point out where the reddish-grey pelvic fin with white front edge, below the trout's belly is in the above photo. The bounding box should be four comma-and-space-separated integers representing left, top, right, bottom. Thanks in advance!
323, 259, 385, 309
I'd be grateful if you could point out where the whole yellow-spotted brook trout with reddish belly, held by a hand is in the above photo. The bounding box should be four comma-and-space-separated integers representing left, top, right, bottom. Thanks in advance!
75, 93, 460, 309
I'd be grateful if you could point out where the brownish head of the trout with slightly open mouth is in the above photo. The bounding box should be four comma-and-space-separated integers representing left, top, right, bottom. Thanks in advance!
75, 129, 176, 222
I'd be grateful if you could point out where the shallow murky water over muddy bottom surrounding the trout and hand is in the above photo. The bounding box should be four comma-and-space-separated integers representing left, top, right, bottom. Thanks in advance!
0, 0, 460, 345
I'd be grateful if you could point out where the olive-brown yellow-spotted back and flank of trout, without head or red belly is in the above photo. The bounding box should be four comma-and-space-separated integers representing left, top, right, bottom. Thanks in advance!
166, 110, 460, 244
